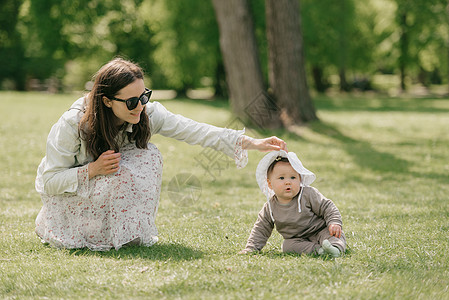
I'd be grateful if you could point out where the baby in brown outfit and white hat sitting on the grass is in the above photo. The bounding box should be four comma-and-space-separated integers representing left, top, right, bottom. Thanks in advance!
239, 150, 346, 257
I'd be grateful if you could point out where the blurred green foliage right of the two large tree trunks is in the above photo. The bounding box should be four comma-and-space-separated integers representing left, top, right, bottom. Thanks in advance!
302, 0, 449, 88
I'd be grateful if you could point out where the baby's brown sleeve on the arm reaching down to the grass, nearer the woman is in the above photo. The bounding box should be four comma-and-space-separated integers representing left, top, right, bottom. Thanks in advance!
245, 203, 274, 251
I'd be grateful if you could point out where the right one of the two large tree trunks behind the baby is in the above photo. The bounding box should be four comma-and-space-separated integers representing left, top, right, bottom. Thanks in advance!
265, 0, 317, 125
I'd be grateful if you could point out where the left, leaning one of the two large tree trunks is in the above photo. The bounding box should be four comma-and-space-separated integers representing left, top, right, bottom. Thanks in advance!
212, 0, 281, 128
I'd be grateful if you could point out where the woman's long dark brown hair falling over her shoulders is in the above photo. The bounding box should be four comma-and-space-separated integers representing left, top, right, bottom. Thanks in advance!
79, 58, 151, 160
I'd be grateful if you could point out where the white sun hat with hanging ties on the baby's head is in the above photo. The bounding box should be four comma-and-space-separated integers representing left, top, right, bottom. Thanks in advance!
256, 150, 316, 222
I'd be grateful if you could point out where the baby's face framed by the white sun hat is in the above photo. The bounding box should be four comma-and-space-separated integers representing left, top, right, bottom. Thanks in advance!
268, 162, 301, 202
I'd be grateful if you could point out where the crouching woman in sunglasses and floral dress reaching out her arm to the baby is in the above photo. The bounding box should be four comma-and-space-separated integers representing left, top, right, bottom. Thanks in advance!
36, 58, 285, 250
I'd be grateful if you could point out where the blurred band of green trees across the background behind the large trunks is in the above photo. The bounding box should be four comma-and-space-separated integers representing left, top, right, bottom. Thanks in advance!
0, 0, 449, 98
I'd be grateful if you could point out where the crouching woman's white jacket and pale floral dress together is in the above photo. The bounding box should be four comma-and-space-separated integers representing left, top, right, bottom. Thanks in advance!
36, 100, 247, 251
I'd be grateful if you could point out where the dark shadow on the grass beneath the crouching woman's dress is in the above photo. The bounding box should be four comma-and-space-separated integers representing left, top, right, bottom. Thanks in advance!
69, 243, 204, 261
